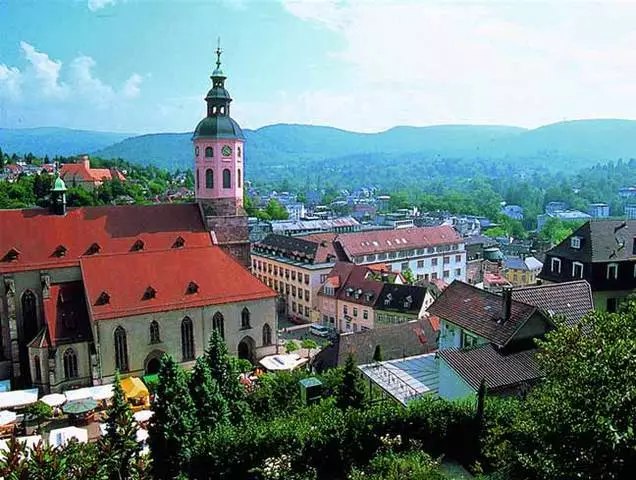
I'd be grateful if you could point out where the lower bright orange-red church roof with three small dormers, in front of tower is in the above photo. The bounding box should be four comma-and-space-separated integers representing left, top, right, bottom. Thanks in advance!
81, 246, 276, 320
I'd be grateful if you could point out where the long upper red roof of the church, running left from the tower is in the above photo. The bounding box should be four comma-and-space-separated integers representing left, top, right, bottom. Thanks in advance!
0, 204, 212, 273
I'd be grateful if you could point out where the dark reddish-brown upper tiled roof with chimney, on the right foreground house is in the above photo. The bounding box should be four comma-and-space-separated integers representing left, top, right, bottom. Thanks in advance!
428, 280, 548, 345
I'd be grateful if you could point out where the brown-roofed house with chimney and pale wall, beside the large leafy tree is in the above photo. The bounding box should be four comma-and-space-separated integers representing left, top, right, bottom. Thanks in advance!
428, 281, 553, 400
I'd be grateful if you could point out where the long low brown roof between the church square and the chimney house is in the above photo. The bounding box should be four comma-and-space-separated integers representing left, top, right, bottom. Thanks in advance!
312, 318, 437, 372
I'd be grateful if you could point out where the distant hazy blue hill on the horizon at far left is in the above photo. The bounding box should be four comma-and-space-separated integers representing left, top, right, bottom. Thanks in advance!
0, 127, 134, 157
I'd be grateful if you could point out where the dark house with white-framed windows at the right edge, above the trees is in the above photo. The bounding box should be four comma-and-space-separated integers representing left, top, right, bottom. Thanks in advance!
540, 220, 636, 312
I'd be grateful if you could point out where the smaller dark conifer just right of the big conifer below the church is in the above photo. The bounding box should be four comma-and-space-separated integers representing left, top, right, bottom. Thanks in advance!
190, 357, 229, 433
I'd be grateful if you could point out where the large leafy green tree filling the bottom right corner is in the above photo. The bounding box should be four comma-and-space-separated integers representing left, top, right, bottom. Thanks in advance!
513, 301, 636, 480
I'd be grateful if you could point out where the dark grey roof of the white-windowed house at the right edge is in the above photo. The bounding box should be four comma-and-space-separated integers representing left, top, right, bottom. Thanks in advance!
544, 220, 636, 264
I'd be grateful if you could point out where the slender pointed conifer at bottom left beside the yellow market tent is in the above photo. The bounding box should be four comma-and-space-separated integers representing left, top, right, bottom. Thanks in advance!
102, 372, 141, 480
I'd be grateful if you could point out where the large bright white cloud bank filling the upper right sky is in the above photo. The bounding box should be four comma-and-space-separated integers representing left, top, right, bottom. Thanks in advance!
282, 0, 636, 131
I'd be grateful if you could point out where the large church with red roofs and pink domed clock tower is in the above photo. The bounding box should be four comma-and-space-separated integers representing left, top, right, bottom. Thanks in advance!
0, 45, 277, 392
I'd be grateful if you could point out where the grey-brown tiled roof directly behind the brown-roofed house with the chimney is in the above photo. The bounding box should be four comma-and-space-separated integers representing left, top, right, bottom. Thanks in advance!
512, 280, 594, 325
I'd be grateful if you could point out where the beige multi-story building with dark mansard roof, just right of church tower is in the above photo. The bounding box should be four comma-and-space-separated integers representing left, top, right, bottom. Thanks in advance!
252, 233, 346, 322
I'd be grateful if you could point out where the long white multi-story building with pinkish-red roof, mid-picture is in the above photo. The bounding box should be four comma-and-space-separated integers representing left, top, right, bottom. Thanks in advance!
336, 226, 466, 283
